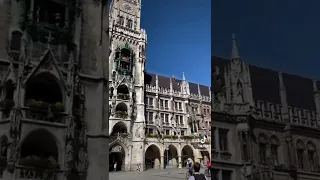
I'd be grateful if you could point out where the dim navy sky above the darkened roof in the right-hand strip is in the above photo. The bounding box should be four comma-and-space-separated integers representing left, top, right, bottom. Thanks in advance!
211, 0, 320, 79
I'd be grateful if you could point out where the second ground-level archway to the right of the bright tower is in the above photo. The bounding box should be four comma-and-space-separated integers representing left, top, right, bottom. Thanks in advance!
163, 144, 178, 168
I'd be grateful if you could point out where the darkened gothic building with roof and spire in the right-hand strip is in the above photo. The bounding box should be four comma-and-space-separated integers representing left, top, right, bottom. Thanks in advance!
211, 35, 320, 180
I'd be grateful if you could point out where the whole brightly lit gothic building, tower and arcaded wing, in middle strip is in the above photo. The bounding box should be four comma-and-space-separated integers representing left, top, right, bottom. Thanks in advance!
109, 0, 211, 171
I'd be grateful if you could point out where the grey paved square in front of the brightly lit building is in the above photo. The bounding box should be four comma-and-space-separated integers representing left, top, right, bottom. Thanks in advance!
109, 169, 211, 180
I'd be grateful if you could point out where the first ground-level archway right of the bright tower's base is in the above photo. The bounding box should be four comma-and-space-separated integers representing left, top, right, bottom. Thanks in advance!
145, 144, 161, 169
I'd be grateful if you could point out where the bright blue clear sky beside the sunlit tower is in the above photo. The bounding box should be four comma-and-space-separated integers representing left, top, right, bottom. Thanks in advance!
141, 0, 211, 85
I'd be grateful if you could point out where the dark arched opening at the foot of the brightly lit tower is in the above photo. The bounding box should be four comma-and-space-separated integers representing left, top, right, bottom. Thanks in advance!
109, 143, 126, 172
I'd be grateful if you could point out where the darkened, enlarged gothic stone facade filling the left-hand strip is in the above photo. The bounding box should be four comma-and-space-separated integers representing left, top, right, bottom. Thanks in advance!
0, 0, 109, 180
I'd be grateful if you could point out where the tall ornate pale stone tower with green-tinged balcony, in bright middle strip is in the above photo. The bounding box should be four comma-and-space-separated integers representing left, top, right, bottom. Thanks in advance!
109, 0, 147, 170
